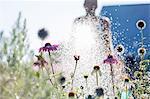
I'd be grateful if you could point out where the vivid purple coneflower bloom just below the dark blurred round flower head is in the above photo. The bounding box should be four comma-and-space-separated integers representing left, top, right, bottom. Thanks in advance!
39, 43, 58, 52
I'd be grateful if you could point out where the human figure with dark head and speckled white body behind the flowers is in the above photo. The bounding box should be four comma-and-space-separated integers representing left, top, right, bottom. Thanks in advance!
62, 0, 125, 97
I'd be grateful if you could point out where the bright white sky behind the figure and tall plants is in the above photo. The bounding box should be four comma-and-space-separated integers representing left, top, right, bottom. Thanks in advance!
0, 0, 150, 50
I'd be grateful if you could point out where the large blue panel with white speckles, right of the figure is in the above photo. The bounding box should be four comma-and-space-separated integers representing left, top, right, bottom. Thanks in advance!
100, 4, 150, 56
